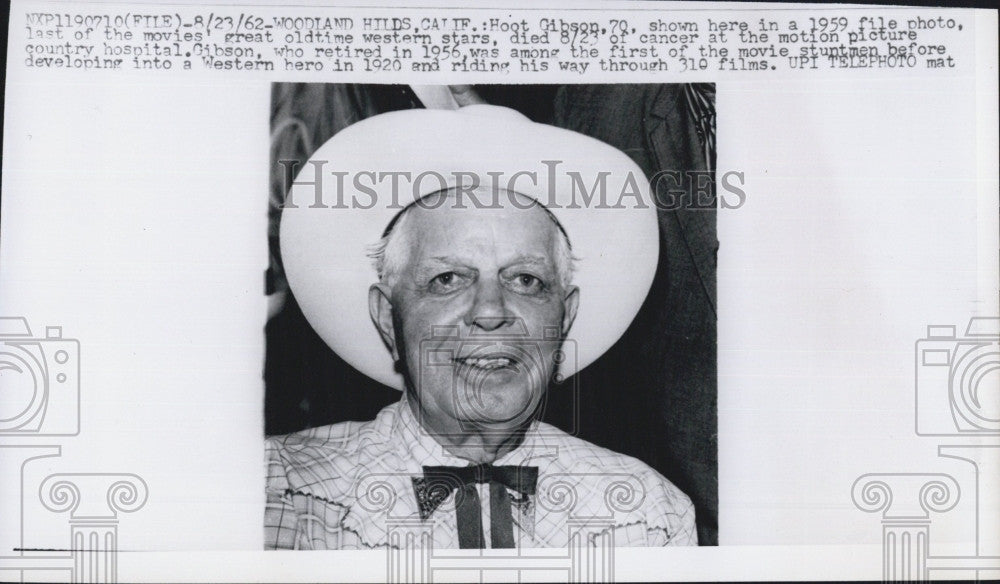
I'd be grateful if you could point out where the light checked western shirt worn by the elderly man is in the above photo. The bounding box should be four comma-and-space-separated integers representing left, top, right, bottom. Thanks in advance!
264, 397, 698, 550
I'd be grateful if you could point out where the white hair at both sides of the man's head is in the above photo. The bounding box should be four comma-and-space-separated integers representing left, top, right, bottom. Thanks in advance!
368, 193, 577, 288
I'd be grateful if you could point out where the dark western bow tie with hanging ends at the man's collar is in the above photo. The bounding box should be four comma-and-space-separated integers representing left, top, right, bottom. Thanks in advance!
413, 464, 538, 549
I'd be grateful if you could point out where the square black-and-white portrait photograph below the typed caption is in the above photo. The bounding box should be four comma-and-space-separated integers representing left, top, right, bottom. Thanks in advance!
265, 84, 718, 549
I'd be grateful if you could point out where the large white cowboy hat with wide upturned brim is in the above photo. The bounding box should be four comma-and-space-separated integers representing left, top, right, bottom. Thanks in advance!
280, 105, 659, 389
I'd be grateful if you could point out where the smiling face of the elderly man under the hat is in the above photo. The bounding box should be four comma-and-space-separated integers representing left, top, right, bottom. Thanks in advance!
373, 189, 578, 431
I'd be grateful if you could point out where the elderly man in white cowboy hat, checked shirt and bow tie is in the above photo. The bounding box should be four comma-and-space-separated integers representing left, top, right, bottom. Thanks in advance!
265, 106, 697, 549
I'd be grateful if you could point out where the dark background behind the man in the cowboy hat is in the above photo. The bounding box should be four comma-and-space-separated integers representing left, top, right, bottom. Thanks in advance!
264, 83, 718, 545
